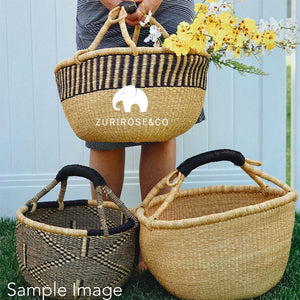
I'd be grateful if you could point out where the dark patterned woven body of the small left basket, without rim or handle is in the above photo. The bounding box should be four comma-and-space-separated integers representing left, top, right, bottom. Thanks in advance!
16, 206, 138, 299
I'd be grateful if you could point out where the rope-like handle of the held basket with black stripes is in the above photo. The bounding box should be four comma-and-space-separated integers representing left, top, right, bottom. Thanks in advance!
73, 1, 169, 64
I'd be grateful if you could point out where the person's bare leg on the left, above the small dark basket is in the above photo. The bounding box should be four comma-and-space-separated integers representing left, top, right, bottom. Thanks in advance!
90, 148, 125, 200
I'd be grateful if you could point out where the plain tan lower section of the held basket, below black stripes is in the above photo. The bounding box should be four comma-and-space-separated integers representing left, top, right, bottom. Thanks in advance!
62, 87, 204, 142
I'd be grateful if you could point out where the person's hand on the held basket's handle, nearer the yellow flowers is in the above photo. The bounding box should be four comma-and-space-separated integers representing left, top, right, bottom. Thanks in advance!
126, 0, 163, 26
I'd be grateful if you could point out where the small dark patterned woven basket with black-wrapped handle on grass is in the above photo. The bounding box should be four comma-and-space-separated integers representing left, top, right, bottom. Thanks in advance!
16, 165, 138, 299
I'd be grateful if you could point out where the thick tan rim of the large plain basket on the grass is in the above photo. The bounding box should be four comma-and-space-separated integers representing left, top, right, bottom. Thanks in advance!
136, 185, 298, 230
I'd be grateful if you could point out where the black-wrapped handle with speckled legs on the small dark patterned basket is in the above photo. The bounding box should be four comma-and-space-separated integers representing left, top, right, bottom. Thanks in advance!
26, 165, 138, 236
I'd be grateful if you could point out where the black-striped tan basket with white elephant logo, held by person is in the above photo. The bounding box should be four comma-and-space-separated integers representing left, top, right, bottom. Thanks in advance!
54, 7, 209, 142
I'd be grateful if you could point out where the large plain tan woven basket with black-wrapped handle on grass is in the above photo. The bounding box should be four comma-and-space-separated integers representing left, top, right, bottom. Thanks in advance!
137, 150, 297, 300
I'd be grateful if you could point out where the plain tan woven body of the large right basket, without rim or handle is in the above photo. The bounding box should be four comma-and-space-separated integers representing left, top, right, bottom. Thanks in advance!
140, 196, 295, 300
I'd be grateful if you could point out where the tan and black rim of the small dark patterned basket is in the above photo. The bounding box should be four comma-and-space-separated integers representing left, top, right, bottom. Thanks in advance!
16, 200, 135, 238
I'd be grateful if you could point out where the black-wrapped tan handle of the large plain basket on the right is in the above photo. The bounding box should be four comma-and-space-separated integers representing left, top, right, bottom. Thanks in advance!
138, 149, 298, 220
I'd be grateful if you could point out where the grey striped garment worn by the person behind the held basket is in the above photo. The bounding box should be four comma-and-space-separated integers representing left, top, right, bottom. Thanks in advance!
76, 0, 205, 150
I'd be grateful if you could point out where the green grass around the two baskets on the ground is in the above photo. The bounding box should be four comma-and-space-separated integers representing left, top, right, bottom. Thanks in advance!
0, 215, 300, 300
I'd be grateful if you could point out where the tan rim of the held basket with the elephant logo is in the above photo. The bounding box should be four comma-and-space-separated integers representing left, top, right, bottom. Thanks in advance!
54, 47, 210, 73
